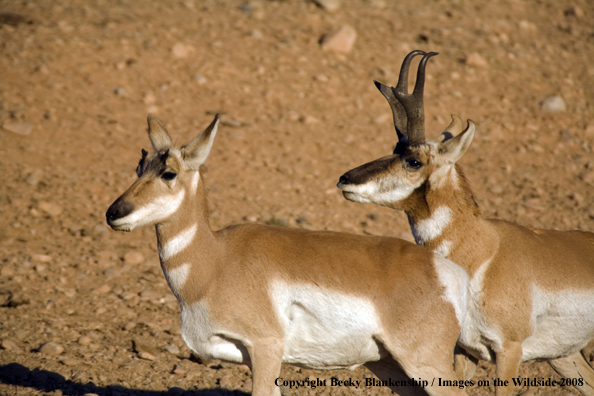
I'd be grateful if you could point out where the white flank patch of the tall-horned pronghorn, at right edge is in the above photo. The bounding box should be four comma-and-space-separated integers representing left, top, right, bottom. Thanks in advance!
522, 285, 594, 361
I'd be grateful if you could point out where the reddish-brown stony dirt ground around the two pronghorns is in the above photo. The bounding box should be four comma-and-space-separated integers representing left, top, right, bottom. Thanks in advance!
0, 0, 594, 396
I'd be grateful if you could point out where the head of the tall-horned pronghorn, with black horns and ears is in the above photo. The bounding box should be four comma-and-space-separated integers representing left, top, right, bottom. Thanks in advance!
337, 50, 475, 212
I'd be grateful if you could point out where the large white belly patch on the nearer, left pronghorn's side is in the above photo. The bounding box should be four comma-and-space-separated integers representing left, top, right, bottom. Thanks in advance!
270, 281, 382, 369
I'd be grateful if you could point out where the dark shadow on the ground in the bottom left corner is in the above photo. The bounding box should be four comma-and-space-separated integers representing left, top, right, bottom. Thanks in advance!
0, 363, 248, 396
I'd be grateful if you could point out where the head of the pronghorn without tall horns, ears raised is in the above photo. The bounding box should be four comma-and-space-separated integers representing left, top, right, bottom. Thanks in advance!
105, 114, 219, 231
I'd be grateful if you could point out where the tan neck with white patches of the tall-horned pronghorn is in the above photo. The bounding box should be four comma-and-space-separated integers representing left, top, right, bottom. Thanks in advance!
406, 166, 499, 274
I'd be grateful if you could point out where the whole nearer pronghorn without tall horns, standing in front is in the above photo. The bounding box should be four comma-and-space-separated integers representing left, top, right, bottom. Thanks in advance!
106, 115, 468, 396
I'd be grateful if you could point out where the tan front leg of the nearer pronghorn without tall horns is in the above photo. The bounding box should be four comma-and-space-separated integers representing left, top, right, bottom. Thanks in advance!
248, 338, 284, 396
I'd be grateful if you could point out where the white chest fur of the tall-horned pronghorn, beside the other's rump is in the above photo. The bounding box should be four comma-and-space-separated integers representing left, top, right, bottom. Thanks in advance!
459, 259, 503, 361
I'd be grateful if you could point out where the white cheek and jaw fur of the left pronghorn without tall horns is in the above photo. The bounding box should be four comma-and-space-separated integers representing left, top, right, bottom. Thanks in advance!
111, 189, 186, 231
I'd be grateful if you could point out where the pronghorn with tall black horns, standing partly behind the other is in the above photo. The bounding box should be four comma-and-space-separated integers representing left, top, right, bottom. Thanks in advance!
338, 51, 594, 396
